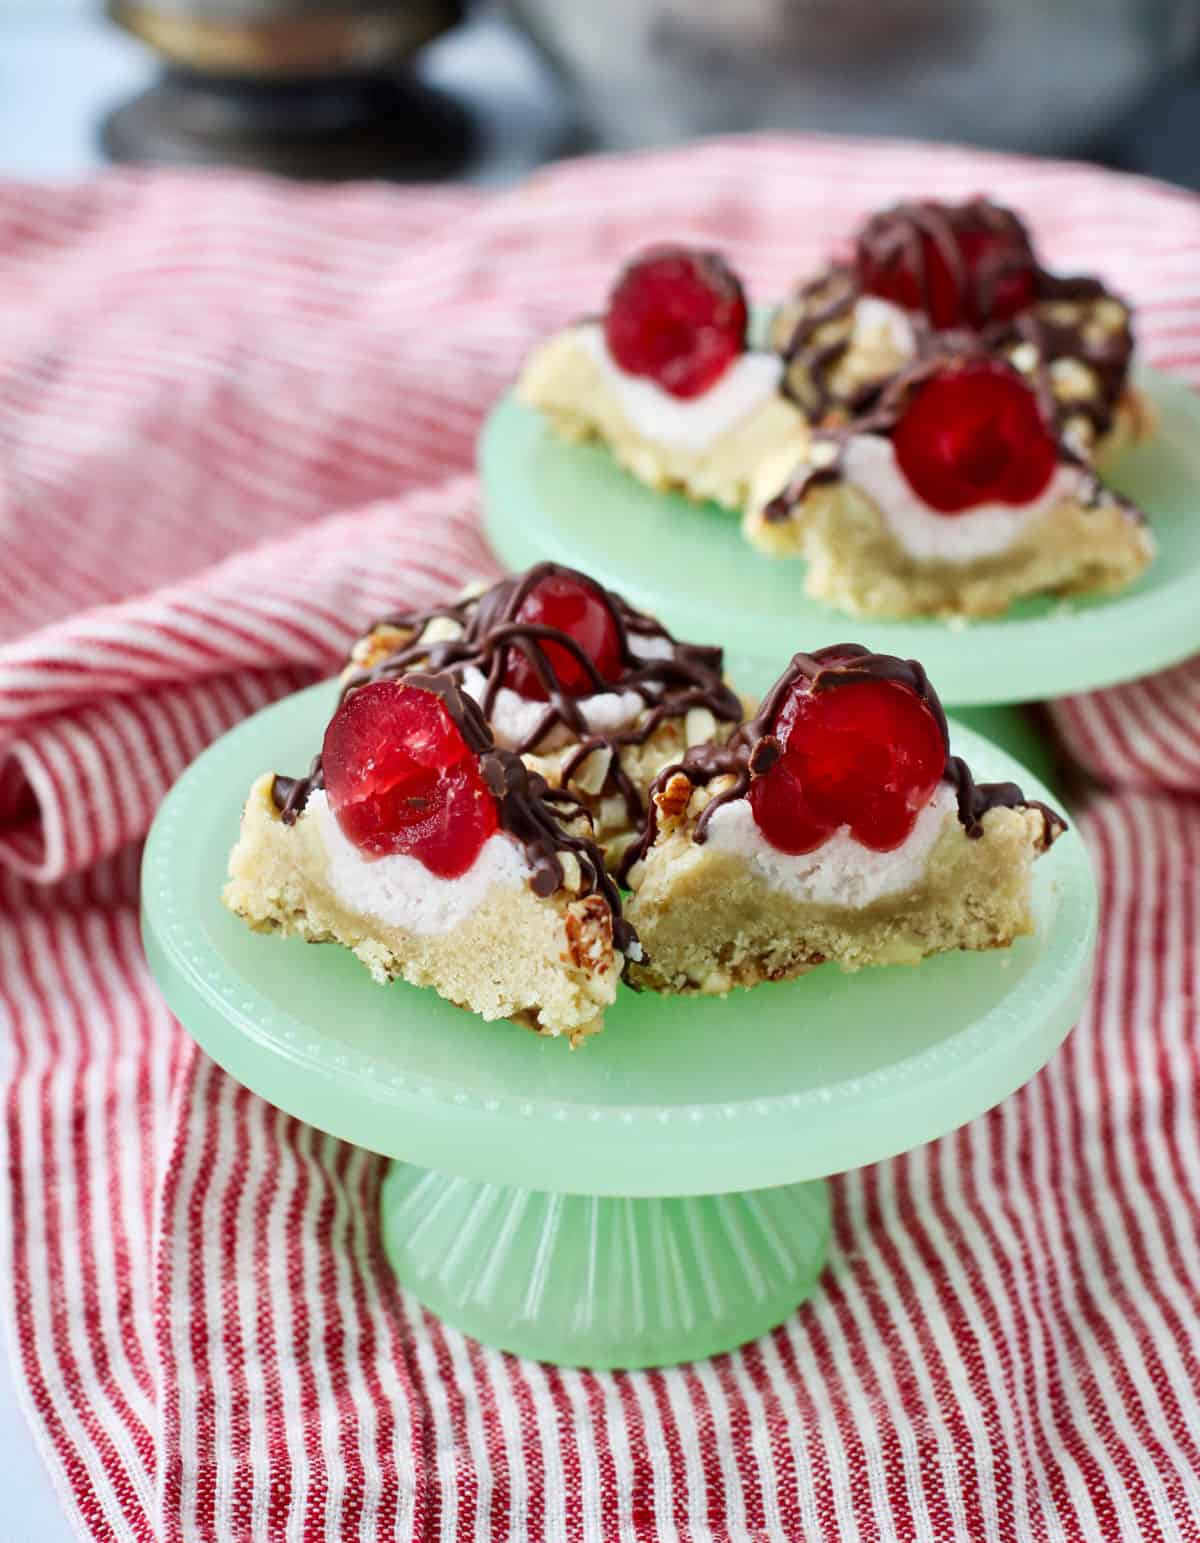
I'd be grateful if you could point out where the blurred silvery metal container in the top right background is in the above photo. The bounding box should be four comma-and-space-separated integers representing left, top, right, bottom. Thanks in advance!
509, 0, 1200, 153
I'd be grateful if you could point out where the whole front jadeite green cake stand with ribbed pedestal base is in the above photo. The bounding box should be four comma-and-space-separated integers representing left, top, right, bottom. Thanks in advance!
142, 684, 1097, 1367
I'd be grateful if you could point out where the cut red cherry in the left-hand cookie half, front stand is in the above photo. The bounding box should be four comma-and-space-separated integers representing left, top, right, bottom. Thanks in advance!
321, 680, 500, 878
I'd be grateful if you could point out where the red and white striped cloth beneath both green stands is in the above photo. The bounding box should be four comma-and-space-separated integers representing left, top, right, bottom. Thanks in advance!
0, 139, 1200, 1543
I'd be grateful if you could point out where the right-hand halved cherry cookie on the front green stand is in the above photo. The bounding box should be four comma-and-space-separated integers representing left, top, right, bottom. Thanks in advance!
628, 643, 1064, 995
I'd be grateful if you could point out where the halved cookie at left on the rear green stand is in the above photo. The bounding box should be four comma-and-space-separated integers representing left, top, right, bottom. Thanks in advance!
517, 247, 807, 509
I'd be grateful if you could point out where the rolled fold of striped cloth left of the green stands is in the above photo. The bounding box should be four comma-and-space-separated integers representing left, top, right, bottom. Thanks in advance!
0, 477, 497, 883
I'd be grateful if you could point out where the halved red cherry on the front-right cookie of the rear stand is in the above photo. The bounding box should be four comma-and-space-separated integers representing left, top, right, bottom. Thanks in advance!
892, 360, 1058, 514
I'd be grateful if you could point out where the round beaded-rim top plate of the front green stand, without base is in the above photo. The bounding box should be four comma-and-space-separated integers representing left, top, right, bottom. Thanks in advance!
143, 685, 1095, 1194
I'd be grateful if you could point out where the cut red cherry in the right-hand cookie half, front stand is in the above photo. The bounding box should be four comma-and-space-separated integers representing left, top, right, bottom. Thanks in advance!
750, 680, 946, 852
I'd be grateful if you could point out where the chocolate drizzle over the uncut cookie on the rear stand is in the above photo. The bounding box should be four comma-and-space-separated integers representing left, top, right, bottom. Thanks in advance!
779, 198, 1134, 435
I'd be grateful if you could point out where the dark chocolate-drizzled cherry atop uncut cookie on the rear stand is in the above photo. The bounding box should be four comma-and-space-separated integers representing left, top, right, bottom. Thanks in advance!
856, 205, 1037, 332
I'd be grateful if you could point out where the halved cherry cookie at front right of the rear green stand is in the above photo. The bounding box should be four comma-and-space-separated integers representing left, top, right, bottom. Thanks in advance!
743, 349, 1155, 617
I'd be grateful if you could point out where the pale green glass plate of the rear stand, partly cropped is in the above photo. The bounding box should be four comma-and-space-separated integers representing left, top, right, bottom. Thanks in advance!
480, 370, 1200, 707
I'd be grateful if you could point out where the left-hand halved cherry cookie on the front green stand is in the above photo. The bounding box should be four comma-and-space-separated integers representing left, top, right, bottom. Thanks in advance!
224, 674, 640, 1043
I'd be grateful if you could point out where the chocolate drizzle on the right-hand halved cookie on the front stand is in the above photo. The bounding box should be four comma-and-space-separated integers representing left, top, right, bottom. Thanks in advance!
620, 643, 1067, 881
